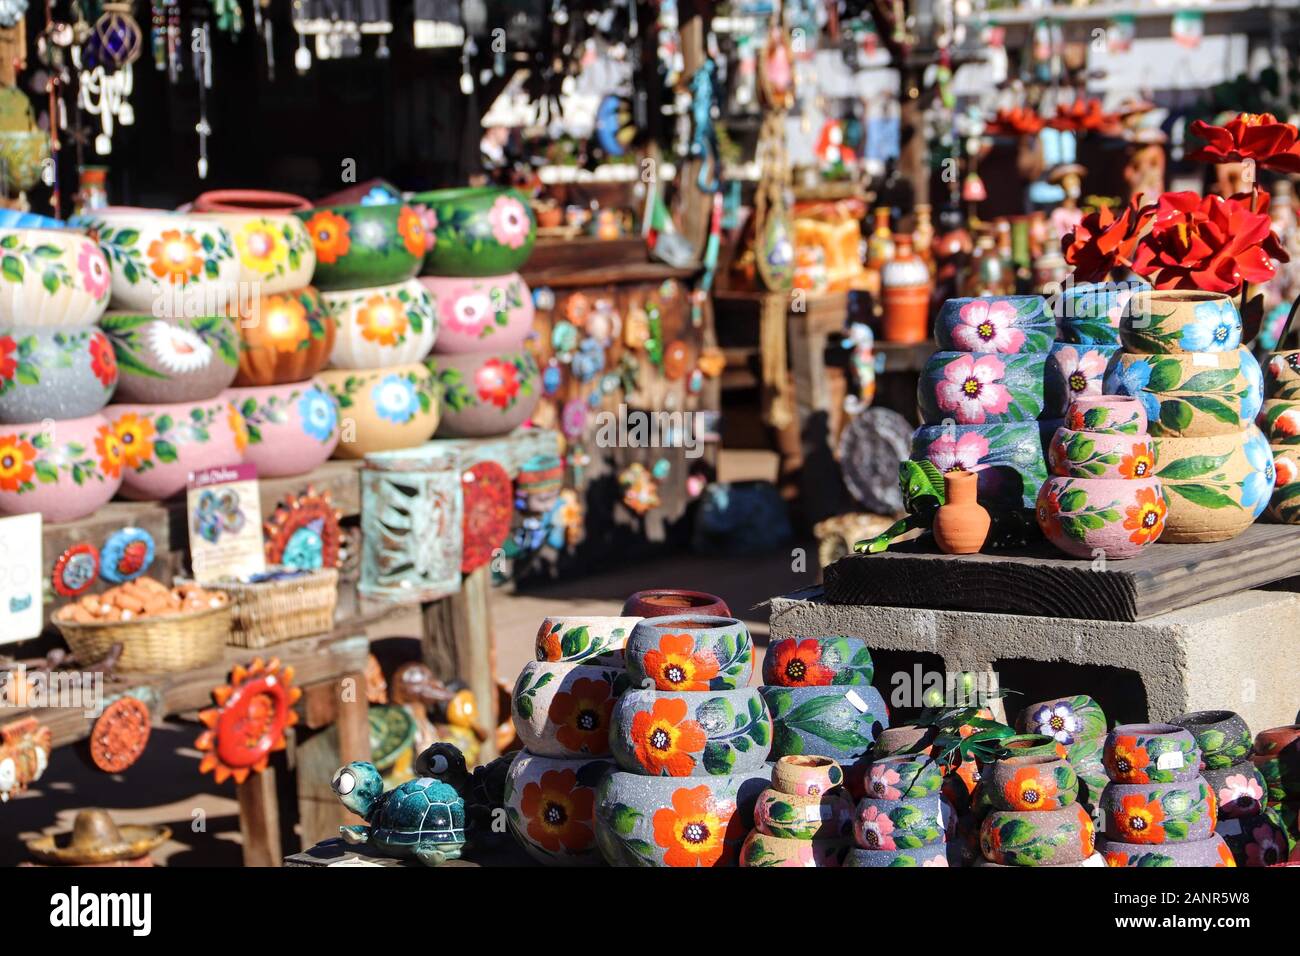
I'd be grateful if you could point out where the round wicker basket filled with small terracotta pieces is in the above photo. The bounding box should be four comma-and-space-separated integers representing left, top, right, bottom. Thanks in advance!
53, 602, 230, 674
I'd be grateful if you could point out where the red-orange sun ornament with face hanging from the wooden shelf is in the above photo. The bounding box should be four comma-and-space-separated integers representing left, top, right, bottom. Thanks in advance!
194, 657, 303, 783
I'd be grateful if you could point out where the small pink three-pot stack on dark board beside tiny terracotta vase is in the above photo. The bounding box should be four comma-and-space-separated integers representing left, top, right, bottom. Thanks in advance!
1036, 395, 1169, 559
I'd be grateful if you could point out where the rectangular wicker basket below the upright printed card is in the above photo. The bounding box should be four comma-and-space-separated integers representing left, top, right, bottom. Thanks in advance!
215, 567, 338, 648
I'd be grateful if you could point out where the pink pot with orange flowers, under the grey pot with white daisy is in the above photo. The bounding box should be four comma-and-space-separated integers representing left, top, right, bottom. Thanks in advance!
104, 395, 248, 501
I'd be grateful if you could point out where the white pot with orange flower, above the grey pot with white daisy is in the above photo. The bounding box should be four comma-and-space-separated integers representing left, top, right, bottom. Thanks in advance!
69, 207, 241, 319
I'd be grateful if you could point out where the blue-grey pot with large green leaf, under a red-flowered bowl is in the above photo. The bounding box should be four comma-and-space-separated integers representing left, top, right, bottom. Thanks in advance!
759, 684, 889, 763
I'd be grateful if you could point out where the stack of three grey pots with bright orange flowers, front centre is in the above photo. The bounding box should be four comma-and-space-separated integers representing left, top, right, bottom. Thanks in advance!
595, 614, 772, 866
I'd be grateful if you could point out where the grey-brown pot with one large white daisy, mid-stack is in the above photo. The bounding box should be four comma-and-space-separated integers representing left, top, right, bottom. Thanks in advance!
100, 312, 239, 405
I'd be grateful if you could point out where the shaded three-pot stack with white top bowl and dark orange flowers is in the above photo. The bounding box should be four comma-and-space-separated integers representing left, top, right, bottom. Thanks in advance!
506, 617, 638, 866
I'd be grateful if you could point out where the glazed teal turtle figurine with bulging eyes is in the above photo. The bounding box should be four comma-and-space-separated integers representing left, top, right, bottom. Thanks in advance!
330, 743, 469, 866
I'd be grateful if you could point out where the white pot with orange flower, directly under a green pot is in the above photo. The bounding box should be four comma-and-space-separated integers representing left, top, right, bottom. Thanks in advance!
321, 278, 438, 368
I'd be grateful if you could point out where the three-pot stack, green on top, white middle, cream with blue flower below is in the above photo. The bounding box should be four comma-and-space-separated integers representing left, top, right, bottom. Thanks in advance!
294, 202, 441, 458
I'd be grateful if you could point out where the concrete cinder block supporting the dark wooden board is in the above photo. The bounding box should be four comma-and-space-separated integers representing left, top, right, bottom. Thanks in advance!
771, 588, 1300, 731
